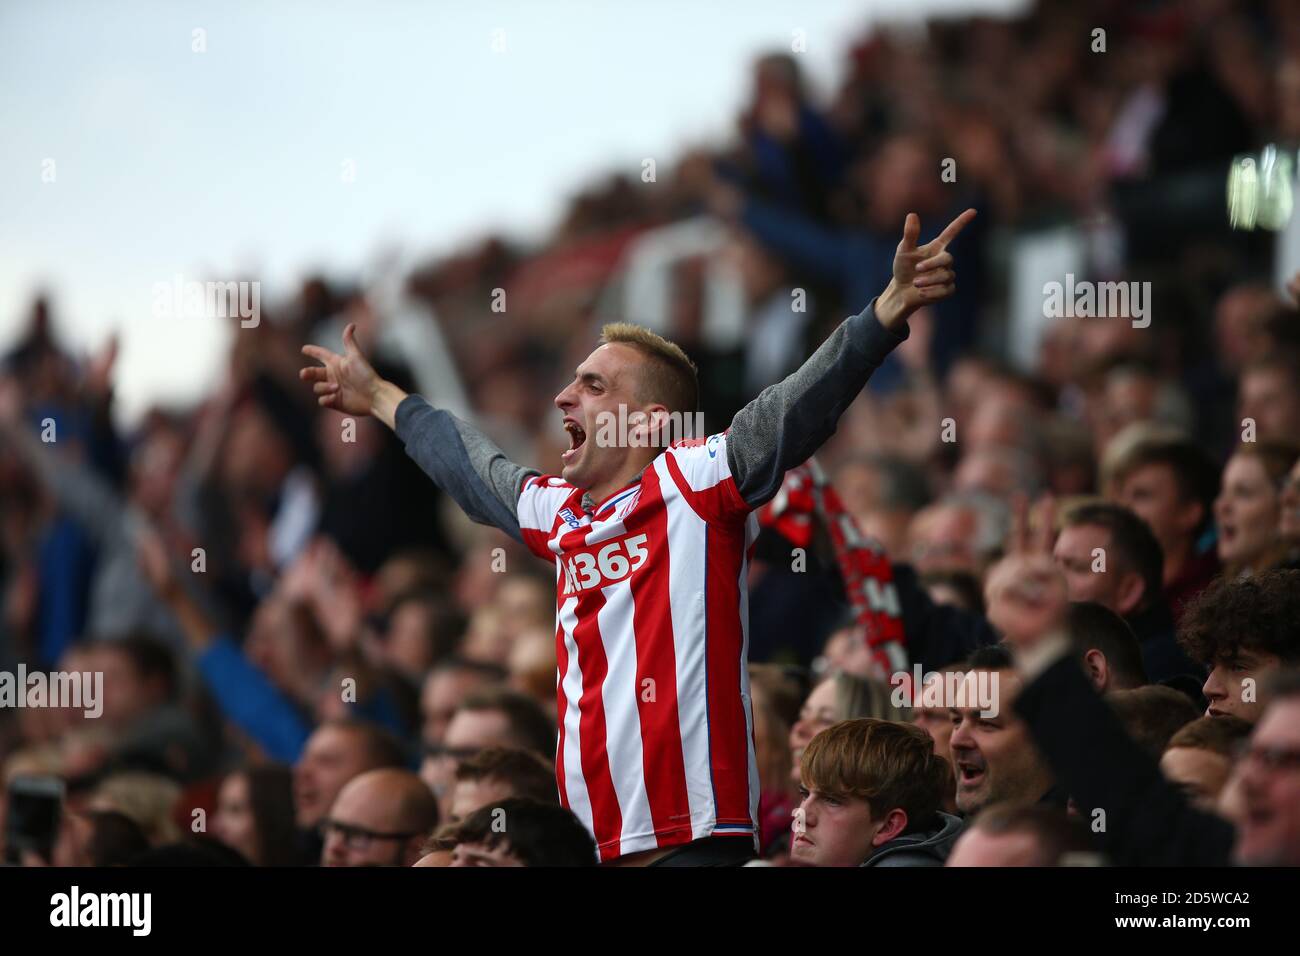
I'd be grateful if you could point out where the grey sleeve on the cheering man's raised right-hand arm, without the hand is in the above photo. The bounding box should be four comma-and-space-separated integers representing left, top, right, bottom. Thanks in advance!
727, 302, 909, 507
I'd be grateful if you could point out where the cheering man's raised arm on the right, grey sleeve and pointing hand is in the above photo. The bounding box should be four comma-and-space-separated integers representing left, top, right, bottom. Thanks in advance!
727, 209, 975, 507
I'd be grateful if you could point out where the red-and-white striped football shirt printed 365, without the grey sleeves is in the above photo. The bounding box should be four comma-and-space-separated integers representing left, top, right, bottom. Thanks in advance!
517, 433, 759, 860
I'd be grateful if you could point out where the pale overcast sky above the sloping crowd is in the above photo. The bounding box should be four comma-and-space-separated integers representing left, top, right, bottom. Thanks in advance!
0, 0, 1022, 421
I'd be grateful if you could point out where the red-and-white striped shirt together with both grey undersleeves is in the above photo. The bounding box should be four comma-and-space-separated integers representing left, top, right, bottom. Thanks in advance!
394, 306, 906, 860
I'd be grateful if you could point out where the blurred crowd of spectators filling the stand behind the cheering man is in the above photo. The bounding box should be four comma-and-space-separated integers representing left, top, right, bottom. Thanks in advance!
0, 0, 1300, 865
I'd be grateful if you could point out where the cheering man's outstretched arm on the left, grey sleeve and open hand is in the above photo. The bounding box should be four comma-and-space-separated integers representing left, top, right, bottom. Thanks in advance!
299, 325, 538, 541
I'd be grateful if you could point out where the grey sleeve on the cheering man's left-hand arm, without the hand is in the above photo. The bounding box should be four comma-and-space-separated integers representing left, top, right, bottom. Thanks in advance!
394, 395, 541, 541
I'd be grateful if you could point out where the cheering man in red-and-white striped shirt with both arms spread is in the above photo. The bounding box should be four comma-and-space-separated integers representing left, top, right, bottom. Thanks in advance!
302, 209, 975, 866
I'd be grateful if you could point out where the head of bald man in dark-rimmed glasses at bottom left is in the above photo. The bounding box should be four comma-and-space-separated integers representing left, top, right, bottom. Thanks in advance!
320, 767, 438, 866
